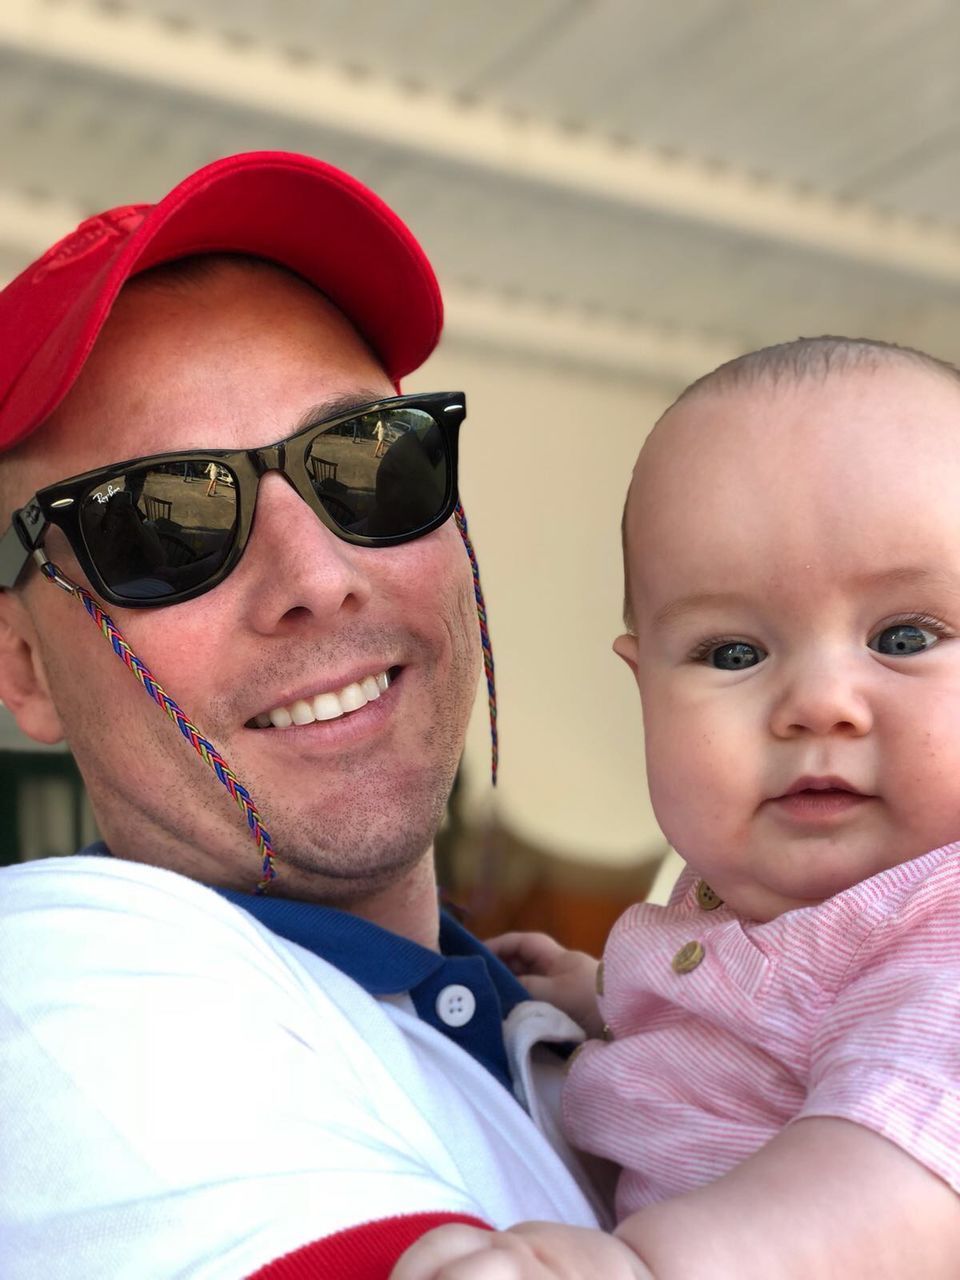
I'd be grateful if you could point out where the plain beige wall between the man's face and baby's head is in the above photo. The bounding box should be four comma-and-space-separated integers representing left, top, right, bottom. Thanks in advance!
404, 342, 677, 863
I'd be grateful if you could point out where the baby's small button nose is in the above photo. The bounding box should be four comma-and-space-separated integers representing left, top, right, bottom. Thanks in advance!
771, 657, 873, 737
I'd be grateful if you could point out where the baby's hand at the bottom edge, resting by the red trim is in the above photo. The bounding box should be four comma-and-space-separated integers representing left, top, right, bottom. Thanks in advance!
390, 1222, 653, 1280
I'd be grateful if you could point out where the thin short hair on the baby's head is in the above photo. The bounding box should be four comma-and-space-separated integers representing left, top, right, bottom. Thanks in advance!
620, 334, 960, 632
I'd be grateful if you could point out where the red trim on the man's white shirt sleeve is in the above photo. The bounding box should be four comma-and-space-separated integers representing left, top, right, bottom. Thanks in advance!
248, 1213, 489, 1280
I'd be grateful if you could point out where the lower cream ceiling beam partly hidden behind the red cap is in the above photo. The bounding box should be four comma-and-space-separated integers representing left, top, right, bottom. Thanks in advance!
0, 189, 727, 385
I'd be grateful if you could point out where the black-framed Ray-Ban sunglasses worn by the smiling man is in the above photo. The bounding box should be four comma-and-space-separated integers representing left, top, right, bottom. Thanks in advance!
0, 392, 466, 608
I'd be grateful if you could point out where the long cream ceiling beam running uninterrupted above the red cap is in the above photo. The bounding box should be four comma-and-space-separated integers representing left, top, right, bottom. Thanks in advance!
0, 0, 960, 283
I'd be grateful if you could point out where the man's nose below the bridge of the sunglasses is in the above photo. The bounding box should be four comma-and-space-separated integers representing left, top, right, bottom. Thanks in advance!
234, 471, 371, 634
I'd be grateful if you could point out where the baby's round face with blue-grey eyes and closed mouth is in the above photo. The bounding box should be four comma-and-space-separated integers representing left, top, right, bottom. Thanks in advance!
617, 362, 960, 919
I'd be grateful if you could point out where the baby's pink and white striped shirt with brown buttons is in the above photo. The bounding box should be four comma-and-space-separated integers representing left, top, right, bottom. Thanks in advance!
563, 844, 960, 1219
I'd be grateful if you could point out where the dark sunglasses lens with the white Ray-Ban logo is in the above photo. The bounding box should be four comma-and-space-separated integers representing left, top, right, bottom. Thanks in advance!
81, 458, 238, 600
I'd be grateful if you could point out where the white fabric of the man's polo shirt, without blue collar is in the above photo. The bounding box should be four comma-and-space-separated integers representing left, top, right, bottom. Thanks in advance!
0, 856, 596, 1280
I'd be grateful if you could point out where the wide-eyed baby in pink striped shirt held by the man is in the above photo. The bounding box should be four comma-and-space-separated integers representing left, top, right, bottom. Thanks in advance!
394, 338, 960, 1280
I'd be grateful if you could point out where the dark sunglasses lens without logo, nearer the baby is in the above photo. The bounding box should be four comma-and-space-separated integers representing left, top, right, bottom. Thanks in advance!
305, 407, 451, 538
